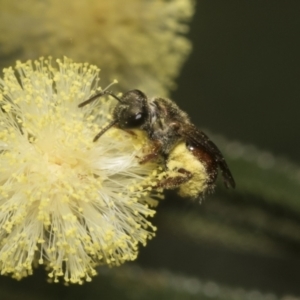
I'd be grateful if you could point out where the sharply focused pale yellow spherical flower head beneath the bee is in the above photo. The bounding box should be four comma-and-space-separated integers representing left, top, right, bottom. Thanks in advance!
0, 58, 164, 283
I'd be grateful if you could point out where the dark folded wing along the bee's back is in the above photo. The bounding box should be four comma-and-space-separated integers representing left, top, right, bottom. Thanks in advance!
178, 124, 235, 188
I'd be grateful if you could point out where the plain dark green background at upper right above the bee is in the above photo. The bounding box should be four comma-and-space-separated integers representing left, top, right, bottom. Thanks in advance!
173, 0, 300, 162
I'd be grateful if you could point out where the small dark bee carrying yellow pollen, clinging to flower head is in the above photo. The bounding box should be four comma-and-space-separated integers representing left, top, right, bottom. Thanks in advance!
79, 90, 235, 198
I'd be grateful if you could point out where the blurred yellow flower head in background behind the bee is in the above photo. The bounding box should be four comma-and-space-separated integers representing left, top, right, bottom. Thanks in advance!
0, 0, 194, 96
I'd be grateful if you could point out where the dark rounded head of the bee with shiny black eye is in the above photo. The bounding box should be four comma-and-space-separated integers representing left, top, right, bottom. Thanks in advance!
113, 90, 149, 129
